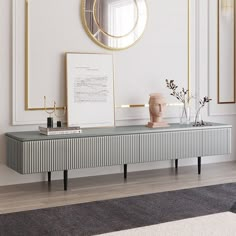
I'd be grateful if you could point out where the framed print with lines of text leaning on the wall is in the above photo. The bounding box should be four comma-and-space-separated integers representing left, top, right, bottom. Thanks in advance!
66, 53, 115, 128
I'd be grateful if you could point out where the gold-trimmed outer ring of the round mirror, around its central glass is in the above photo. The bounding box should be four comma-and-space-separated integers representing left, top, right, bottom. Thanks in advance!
81, 0, 148, 50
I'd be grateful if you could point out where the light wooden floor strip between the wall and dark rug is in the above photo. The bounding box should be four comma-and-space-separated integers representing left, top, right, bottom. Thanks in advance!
0, 162, 236, 214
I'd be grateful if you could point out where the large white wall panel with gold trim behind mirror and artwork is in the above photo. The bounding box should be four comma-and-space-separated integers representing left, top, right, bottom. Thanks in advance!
13, 0, 192, 125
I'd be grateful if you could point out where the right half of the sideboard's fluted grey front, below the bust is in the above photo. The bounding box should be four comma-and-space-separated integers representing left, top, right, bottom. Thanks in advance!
140, 128, 231, 162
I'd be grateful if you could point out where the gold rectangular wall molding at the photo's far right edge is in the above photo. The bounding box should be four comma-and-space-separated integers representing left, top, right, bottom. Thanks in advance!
217, 0, 236, 104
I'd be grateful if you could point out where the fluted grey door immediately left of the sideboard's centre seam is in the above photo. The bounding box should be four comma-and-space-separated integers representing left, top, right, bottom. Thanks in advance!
65, 135, 139, 169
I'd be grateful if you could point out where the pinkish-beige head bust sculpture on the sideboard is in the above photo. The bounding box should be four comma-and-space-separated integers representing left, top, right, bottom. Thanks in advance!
147, 93, 169, 128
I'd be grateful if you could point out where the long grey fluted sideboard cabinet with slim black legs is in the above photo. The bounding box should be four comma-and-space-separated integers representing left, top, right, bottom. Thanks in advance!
6, 123, 232, 190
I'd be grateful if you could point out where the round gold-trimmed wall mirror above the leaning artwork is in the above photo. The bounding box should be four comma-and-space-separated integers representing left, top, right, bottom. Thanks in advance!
82, 0, 147, 50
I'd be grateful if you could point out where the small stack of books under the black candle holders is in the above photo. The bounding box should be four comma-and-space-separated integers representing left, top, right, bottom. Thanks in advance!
39, 126, 82, 135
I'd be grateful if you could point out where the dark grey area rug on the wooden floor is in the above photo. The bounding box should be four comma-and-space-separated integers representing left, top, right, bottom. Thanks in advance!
0, 183, 236, 236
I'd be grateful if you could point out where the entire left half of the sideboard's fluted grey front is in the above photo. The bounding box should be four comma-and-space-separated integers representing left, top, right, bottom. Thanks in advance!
23, 135, 139, 174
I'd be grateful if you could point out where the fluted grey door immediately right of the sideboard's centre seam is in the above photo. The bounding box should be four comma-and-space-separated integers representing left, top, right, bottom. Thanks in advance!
140, 130, 202, 162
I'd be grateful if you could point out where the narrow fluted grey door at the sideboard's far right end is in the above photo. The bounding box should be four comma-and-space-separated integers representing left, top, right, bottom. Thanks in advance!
202, 128, 231, 156
